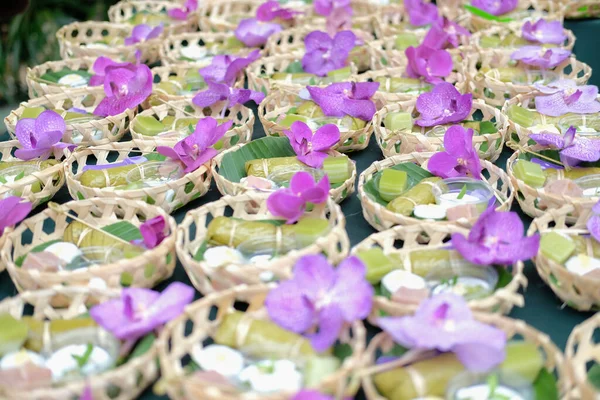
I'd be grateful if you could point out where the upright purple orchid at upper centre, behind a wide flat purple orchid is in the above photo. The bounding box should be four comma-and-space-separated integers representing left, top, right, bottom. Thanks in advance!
302, 31, 356, 76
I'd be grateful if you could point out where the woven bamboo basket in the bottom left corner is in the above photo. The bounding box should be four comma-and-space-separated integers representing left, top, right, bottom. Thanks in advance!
0, 286, 159, 400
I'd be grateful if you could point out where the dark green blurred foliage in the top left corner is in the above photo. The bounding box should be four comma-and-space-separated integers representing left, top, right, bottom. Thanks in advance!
0, 0, 117, 106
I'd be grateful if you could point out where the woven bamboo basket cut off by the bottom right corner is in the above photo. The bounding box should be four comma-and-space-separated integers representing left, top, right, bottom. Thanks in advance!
565, 313, 600, 400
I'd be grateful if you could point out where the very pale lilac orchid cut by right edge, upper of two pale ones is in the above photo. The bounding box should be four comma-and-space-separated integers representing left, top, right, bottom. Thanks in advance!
535, 79, 600, 117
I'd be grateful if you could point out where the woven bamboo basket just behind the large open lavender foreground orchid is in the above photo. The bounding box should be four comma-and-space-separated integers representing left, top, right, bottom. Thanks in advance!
177, 191, 350, 294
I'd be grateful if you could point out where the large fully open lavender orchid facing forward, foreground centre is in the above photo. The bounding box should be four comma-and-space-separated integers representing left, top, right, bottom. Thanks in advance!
265, 254, 373, 352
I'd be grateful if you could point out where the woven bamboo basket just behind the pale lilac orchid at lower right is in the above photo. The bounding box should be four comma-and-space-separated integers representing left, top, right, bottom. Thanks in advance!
351, 223, 527, 322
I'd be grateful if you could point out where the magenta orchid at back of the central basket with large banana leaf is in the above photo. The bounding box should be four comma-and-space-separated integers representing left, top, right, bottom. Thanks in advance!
283, 121, 340, 168
